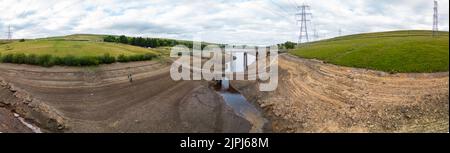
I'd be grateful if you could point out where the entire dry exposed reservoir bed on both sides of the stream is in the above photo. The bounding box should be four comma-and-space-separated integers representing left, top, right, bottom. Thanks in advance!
0, 54, 449, 132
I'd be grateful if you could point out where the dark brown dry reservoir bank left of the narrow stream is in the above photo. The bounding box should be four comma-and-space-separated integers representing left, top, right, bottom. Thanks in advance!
0, 61, 251, 132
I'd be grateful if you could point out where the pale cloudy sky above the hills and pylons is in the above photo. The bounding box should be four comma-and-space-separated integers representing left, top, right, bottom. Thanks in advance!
0, 0, 449, 45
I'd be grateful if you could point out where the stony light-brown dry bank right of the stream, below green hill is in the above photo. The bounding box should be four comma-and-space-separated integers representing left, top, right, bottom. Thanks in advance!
232, 54, 449, 132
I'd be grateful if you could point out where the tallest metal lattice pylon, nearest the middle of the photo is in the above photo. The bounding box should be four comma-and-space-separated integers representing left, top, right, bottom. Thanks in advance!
296, 4, 312, 44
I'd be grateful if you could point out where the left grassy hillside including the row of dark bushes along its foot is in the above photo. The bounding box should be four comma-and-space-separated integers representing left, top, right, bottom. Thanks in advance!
0, 35, 160, 66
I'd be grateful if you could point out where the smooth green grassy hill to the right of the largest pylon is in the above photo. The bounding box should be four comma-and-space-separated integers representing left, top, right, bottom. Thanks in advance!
289, 31, 449, 73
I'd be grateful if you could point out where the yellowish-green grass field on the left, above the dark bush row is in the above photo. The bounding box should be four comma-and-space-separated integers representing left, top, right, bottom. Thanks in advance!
0, 35, 158, 57
